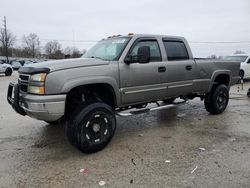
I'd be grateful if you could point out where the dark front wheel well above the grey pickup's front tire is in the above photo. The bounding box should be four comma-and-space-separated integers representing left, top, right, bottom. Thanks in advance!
65, 84, 116, 115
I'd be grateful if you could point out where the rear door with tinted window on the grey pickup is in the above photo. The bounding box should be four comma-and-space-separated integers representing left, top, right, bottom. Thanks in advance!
163, 38, 195, 96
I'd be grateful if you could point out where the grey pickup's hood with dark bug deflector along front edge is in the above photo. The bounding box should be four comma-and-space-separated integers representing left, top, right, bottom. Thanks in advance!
19, 58, 109, 74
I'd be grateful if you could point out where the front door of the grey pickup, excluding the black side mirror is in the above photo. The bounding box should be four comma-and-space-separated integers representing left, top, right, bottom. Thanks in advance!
119, 37, 166, 104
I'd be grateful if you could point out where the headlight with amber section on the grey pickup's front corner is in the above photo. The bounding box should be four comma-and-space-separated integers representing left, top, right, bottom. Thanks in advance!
28, 73, 47, 95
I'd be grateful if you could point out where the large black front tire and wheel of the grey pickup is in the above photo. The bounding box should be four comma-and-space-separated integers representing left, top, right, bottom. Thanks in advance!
66, 102, 116, 153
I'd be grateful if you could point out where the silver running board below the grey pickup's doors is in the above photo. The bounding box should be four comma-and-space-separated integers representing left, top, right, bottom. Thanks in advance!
116, 100, 188, 117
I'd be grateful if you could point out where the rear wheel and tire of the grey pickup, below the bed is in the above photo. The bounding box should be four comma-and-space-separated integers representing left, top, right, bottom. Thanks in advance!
204, 84, 229, 114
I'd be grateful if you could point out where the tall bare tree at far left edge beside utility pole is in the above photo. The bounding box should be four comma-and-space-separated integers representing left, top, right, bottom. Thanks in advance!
0, 29, 16, 60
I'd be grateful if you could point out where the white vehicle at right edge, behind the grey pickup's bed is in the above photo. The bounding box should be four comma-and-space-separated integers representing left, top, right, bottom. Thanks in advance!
226, 54, 250, 79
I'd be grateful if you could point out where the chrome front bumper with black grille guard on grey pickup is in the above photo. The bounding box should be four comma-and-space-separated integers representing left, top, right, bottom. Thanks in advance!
7, 83, 66, 121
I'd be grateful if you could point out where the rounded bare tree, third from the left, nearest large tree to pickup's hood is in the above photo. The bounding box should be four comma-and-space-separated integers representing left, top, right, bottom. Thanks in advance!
44, 40, 64, 59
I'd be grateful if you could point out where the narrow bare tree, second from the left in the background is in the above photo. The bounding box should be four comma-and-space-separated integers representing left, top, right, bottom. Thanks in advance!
23, 33, 40, 58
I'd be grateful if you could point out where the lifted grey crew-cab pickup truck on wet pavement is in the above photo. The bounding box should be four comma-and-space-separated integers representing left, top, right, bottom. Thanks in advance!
7, 34, 240, 153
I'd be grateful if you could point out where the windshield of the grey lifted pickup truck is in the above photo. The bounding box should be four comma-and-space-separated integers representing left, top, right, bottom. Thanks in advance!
82, 37, 130, 61
